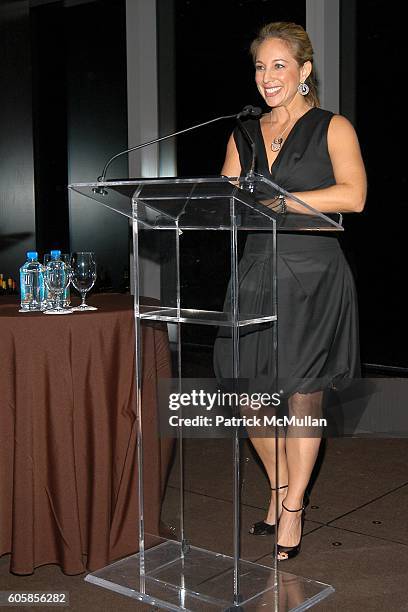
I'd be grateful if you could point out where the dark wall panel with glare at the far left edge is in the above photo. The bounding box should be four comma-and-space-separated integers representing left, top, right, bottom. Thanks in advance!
0, 0, 35, 280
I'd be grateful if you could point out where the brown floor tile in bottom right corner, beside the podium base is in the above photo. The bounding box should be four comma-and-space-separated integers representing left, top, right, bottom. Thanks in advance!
259, 527, 408, 612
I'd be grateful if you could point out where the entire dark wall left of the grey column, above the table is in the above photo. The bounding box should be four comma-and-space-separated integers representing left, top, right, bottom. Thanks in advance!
0, 0, 129, 288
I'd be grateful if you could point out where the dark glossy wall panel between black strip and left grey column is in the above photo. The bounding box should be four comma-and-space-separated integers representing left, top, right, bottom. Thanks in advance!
66, 0, 129, 287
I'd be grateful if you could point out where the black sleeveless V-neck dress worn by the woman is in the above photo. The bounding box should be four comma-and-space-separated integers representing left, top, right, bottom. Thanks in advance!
214, 108, 360, 395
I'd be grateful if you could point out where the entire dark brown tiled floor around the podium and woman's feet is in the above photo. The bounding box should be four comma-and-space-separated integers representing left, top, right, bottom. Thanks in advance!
0, 439, 408, 612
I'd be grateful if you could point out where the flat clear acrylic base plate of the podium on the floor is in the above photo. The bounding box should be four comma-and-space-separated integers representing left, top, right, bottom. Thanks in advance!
85, 540, 334, 612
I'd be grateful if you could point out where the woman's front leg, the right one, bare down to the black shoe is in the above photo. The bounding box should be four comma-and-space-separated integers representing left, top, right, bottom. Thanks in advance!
278, 391, 323, 556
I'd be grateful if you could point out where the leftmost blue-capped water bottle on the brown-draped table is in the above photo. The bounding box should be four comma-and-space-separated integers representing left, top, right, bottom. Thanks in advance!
20, 251, 45, 312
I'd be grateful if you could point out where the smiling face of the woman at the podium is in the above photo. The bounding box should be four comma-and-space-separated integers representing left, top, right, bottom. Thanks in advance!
255, 38, 311, 107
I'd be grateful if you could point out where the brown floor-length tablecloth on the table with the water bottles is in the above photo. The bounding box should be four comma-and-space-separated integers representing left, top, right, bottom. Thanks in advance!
0, 295, 172, 574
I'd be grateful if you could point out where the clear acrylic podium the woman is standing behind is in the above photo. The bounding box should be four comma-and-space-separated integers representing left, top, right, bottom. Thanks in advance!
69, 175, 342, 612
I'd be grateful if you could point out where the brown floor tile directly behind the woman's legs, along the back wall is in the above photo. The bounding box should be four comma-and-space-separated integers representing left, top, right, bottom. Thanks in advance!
170, 438, 408, 523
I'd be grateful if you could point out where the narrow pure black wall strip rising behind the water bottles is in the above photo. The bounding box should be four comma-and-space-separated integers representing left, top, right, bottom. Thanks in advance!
30, 2, 70, 253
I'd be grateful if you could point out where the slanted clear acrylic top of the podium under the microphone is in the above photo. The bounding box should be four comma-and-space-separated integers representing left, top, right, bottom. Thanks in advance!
69, 175, 343, 232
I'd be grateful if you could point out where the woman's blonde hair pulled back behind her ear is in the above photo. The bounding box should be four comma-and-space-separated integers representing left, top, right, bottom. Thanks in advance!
250, 21, 320, 106
